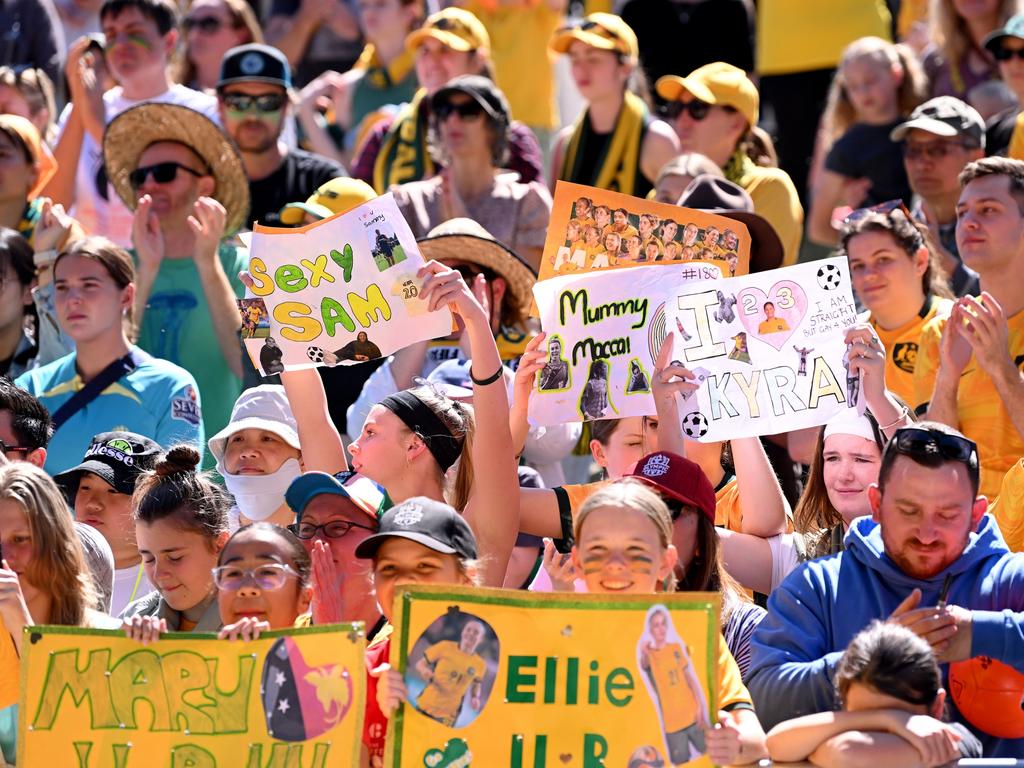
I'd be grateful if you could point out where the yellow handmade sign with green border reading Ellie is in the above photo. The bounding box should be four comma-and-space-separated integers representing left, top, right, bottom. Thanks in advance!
385, 587, 724, 768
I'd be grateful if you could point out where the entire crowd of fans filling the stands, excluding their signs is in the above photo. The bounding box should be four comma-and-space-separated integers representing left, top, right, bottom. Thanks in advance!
0, 0, 1024, 766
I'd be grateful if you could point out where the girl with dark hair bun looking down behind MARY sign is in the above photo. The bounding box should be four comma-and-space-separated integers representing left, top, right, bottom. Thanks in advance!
121, 445, 230, 643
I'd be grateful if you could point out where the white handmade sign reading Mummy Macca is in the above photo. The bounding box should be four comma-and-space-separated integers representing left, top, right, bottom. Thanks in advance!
529, 263, 712, 426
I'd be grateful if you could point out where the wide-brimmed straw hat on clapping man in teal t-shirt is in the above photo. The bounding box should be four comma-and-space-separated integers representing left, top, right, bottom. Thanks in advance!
103, 103, 249, 234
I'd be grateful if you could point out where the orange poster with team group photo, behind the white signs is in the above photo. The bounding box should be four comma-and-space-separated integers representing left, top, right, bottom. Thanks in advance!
539, 181, 751, 280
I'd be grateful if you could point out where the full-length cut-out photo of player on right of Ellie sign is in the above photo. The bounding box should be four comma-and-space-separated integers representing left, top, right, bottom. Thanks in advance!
637, 605, 710, 765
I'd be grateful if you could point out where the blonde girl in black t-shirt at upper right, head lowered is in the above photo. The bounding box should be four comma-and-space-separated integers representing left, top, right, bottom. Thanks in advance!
808, 37, 926, 246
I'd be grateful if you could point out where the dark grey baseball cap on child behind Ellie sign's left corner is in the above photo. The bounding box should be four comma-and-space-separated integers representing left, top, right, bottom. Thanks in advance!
355, 496, 476, 560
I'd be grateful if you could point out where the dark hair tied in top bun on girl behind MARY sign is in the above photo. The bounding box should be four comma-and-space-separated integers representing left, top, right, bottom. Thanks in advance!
132, 444, 231, 541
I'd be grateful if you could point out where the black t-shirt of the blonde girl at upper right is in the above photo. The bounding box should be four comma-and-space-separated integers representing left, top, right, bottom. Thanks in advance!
825, 120, 912, 207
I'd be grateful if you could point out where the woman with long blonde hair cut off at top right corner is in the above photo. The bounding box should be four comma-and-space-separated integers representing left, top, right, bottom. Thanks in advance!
924, 0, 1021, 99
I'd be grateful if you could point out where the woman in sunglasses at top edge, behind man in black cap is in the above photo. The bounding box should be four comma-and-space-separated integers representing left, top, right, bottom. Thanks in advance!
174, 0, 263, 92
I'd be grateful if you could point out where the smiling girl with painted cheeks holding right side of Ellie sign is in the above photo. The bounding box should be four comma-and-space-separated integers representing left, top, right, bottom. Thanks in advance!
572, 480, 767, 765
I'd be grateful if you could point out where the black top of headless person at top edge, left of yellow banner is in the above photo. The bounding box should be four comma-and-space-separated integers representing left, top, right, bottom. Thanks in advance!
622, 0, 754, 101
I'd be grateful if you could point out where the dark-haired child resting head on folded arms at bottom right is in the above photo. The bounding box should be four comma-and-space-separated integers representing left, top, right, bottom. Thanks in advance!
768, 621, 981, 768
